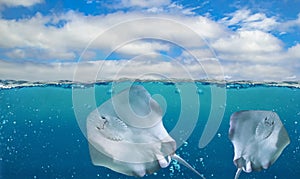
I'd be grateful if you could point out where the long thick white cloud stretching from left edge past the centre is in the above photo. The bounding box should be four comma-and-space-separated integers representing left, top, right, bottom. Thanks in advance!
0, 11, 225, 60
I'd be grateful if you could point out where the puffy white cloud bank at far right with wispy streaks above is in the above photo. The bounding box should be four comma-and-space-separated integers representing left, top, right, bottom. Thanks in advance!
216, 9, 300, 75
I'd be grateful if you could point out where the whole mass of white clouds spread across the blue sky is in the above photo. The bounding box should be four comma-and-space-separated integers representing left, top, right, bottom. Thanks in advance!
0, 0, 300, 81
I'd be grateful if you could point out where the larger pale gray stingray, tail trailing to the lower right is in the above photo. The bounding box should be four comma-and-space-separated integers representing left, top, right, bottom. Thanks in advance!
87, 86, 204, 178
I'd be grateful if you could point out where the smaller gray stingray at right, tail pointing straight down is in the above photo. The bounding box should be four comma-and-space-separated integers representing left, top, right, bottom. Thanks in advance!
229, 110, 290, 179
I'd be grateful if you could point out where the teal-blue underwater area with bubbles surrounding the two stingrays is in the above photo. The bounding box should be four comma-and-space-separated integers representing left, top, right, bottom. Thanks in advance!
0, 81, 300, 178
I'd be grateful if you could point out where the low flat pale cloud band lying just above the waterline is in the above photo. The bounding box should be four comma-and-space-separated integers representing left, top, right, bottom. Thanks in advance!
0, 58, 218, 81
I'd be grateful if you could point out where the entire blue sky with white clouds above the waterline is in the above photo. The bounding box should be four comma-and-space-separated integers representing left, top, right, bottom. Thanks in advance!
0, 0, 300, 82
